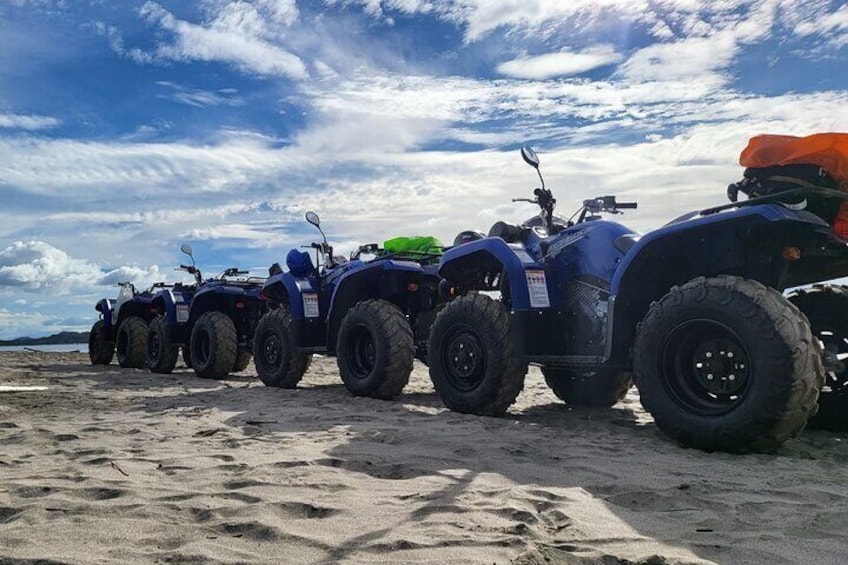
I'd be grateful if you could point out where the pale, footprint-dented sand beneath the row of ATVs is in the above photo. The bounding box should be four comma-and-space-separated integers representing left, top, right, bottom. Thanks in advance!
0, 352, 848, 564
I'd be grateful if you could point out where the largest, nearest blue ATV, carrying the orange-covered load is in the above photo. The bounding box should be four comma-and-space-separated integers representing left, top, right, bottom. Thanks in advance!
429, 147, 848, 452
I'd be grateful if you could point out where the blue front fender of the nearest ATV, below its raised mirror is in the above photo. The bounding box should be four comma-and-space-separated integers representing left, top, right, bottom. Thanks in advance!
439, 237, 542, 311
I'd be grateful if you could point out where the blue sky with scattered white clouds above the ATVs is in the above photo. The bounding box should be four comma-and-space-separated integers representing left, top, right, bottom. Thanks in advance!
0, 0, 848, 339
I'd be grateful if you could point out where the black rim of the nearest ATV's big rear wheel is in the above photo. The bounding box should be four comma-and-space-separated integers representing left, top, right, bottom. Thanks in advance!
660, 319, 753, 416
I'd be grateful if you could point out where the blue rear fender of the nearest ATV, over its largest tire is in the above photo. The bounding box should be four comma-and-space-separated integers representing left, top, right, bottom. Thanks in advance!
607, 204, 836, 363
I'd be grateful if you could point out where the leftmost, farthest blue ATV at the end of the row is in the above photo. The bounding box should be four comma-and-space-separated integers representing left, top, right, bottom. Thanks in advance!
88, 282, 161, 369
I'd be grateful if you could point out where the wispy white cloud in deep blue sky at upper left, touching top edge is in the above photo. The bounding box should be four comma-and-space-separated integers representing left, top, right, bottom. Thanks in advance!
131, 1, 309, 79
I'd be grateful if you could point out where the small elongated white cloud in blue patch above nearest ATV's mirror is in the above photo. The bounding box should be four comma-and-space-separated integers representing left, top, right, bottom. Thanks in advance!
497, 45, 621, 80
